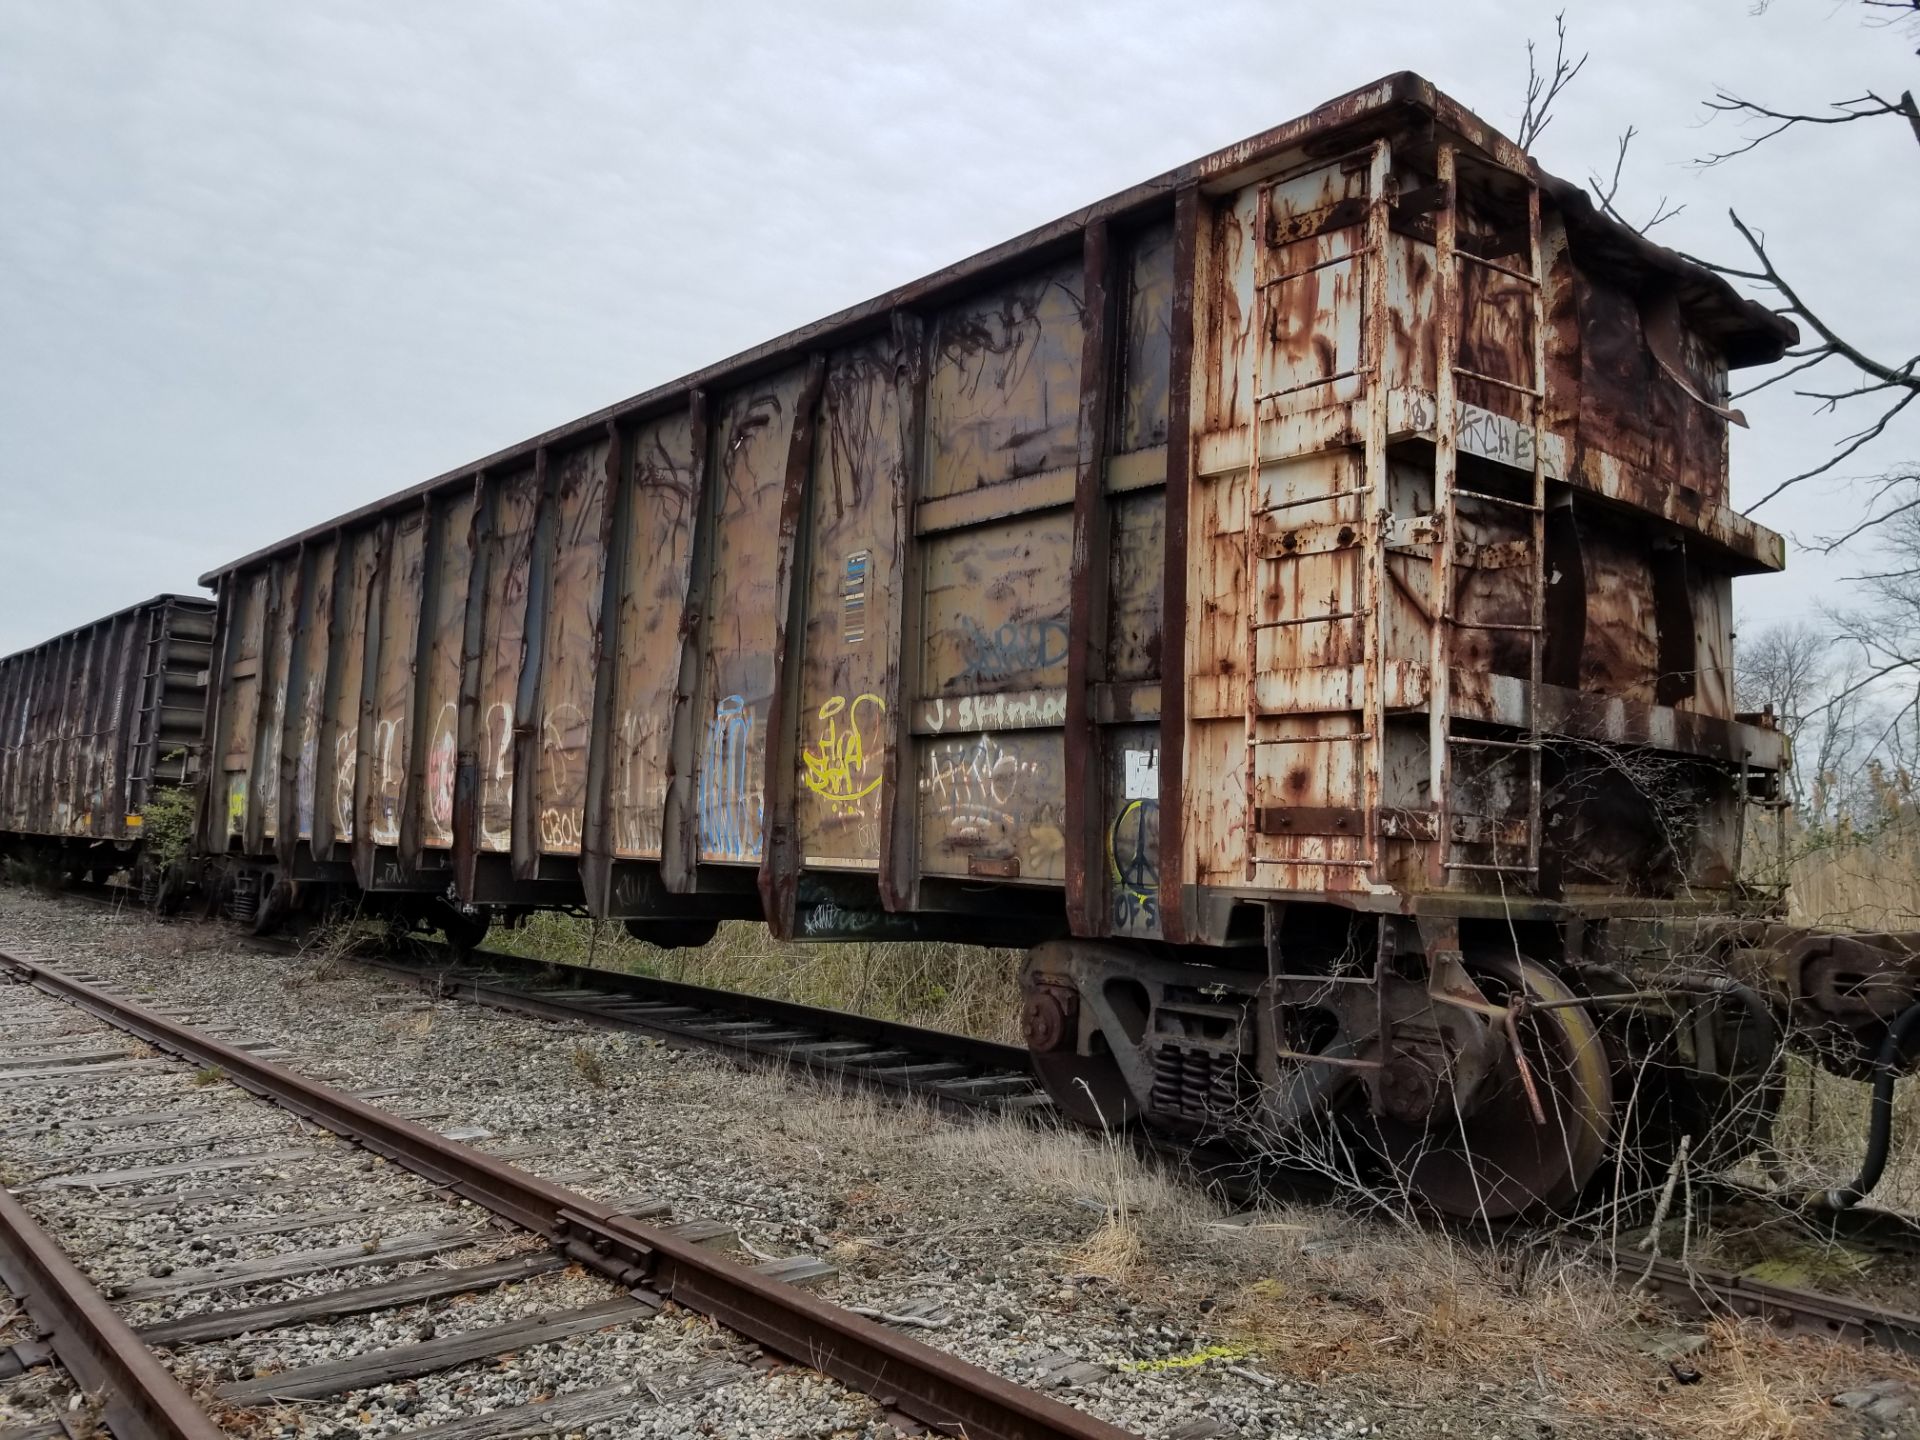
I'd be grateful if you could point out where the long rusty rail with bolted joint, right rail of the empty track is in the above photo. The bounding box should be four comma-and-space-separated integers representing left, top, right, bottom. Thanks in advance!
0, 952, 1129, 1440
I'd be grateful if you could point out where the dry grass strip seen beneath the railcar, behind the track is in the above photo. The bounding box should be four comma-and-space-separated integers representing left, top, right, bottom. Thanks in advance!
488, 914, 1021, 1041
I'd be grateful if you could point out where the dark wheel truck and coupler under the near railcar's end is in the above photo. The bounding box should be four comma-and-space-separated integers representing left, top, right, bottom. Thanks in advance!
1021, 906, 1920, 1219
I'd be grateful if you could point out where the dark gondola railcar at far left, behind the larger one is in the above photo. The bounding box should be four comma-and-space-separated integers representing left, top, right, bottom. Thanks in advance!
0, 595, 213, 877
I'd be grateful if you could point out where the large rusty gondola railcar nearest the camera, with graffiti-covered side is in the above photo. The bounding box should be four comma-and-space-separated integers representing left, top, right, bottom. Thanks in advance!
183, 75, 1905, 1212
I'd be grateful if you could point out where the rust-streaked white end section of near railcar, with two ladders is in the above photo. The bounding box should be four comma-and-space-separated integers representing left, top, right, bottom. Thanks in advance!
1181, 129, 1786, 939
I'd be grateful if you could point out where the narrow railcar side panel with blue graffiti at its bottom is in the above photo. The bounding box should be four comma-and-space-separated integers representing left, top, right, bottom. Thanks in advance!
697, 371, 804, 864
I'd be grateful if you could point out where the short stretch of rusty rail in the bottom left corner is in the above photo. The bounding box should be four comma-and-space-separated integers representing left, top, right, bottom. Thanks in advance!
0, 1187, 225, 1440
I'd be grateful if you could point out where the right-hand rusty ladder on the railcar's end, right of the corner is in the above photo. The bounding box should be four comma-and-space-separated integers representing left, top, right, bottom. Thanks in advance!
1428, 144, 1548, 887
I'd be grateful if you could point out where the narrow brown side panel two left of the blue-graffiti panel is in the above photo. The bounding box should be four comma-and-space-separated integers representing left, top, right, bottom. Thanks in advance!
536, 442, 607, 854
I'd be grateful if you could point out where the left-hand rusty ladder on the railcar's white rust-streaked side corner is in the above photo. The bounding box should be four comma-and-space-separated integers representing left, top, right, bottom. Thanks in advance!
1242, 140, 1392, 881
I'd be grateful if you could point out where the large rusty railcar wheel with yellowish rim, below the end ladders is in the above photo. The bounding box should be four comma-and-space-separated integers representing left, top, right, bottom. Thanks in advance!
1379, 960, 1613, 1219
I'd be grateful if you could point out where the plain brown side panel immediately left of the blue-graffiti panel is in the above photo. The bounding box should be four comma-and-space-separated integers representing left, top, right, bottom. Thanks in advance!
607, 411, 695, 860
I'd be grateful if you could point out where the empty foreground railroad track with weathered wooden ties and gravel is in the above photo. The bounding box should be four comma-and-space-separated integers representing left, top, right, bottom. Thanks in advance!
0, 954, 1125, 1440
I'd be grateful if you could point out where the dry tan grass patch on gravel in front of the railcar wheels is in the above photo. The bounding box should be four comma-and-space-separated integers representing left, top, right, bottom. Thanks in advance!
729, 1075, 1920, 1440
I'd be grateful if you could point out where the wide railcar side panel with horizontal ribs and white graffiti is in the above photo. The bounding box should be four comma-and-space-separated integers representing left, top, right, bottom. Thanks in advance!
912, 263, 1085, 881
